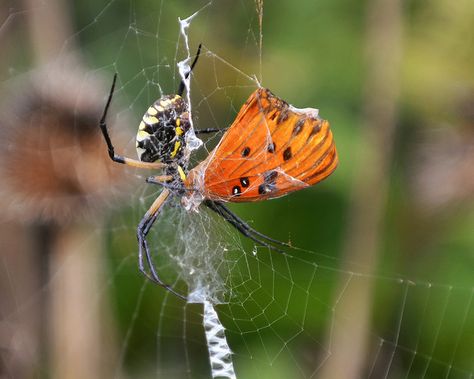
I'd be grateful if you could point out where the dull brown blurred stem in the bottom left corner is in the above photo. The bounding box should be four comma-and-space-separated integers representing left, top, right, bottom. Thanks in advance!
0, 224, 46, 378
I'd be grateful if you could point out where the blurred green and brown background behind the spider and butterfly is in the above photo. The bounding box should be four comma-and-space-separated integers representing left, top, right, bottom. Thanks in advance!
0, 0, 474, 379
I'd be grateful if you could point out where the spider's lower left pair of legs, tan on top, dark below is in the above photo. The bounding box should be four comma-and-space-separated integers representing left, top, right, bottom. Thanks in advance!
137, 188, 186, 300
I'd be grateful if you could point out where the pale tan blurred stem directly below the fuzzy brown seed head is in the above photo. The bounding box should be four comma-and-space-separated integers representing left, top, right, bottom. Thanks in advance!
49, 224, 110, 379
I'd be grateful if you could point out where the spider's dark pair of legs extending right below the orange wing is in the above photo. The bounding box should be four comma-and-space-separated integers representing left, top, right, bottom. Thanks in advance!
205, 201, 289, 253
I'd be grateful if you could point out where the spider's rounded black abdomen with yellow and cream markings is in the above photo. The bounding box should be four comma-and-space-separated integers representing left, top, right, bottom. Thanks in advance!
136, 95, 191, 163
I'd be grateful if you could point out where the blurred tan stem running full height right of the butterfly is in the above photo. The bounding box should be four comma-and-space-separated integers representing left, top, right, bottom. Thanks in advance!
319, 0, 402, 379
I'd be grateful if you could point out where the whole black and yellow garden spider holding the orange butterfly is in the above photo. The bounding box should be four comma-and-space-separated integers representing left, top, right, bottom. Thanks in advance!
99, 45, 289, 300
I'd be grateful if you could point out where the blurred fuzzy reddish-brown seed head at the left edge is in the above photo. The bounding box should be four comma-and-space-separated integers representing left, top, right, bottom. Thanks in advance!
0, 66, 129, 223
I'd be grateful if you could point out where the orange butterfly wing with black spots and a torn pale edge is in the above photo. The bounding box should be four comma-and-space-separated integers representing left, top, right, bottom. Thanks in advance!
186, 88, 338, 202
